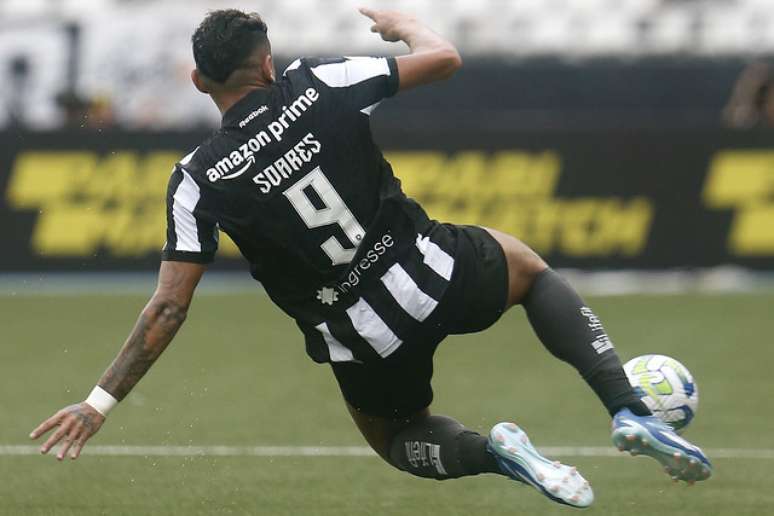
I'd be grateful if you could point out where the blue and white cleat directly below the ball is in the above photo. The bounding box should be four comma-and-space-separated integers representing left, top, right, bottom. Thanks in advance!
613, 408, 712, 484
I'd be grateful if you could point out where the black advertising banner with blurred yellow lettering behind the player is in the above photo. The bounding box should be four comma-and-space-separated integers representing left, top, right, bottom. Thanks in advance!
0, 129, 774, 272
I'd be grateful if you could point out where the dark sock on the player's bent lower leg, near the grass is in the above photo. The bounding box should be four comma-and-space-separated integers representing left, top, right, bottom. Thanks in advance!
390, 416, 502, 480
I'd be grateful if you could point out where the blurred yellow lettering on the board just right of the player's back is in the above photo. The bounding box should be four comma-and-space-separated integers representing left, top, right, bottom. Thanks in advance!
387, 151, 654, 257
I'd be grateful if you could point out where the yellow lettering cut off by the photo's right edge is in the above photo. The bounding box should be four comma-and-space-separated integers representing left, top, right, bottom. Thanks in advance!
703, 150, 774, 256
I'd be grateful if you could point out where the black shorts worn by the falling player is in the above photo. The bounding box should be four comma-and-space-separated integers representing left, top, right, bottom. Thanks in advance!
331, 224, 508, 418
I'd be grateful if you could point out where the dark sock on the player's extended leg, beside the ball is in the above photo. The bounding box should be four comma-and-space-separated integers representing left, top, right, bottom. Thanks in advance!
522, 269, 650, 415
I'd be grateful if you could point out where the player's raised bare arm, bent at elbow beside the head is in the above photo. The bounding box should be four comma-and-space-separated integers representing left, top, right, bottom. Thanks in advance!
360, 8, 462, 91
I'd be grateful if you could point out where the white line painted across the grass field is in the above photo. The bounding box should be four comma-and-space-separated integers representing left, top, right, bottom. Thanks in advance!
0, 445, 774, 460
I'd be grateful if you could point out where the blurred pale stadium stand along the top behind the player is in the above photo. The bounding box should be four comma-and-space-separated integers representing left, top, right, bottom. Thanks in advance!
0, 0, 774, 129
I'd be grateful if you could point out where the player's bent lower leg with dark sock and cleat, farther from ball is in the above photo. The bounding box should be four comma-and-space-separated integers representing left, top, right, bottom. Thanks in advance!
347, 404, 594, 507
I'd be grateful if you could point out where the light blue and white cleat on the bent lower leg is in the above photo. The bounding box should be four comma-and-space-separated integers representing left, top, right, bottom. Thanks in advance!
487, 423, 594, 507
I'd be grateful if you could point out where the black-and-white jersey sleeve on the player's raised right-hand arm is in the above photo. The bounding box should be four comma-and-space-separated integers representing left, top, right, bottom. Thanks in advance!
285, 57, 400, 115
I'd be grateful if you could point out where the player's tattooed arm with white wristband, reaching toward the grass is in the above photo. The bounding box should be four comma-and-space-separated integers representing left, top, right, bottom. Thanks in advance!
30, 261, 205, 460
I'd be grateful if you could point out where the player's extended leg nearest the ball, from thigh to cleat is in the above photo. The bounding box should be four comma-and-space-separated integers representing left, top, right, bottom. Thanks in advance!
488, 230, 711, 482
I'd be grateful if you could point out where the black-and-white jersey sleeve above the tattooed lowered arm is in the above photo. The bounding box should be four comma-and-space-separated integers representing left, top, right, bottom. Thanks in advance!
161, 167, 218, 263
